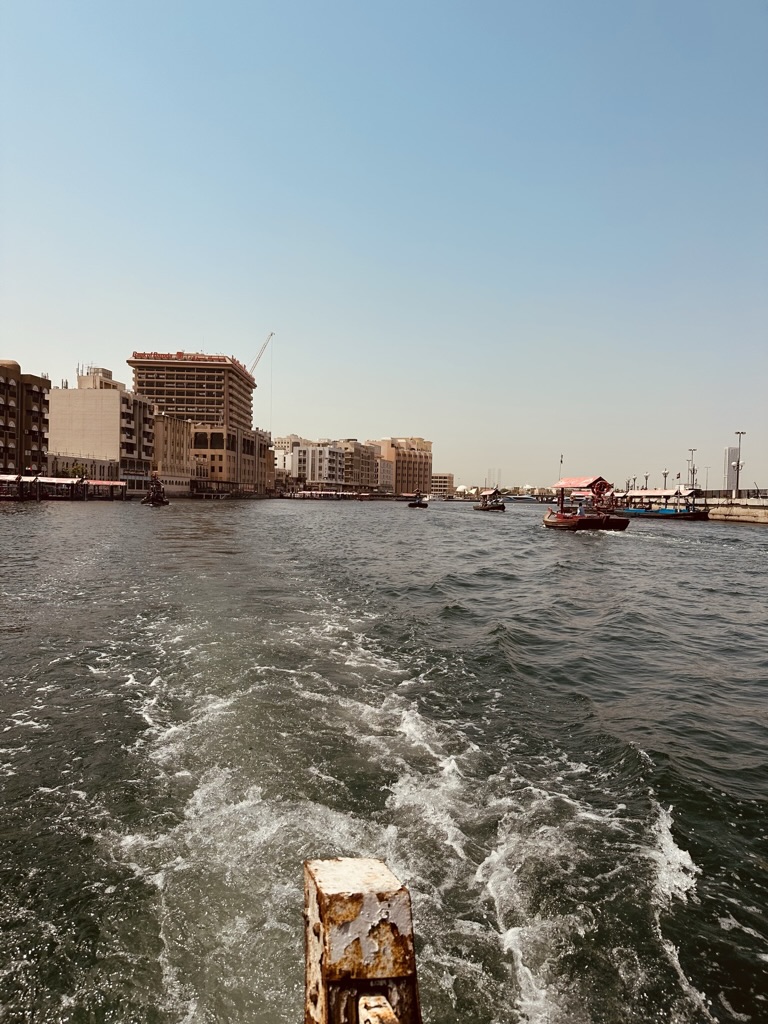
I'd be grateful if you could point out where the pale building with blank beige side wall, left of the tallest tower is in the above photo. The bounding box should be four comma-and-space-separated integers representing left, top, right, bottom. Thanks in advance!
48, 367, 155, 494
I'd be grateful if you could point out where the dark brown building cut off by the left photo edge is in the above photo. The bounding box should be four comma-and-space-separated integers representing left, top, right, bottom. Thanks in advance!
0, 359, 50, 474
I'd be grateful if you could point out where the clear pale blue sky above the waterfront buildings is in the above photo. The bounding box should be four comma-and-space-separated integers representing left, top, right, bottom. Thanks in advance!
0, 0, 768, 487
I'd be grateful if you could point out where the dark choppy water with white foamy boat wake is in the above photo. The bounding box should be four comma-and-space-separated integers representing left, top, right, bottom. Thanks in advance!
0, 502, 768, 1024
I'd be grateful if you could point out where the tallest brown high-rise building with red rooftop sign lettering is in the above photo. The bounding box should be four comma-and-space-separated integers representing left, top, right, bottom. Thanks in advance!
128, 352, 274, 495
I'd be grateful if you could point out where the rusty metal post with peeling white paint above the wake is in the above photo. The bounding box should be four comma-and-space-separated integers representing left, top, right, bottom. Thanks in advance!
304, 857, 421, 1024
